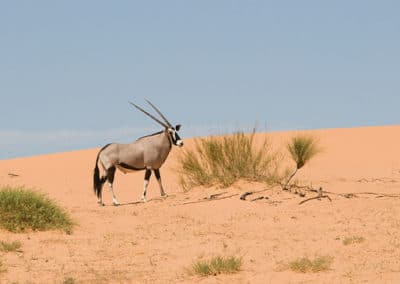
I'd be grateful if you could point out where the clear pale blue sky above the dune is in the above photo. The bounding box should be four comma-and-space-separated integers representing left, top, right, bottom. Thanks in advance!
0, 0, 400, 159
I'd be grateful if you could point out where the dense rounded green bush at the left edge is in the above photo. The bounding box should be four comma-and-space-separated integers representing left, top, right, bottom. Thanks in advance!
0, 187, 73, 233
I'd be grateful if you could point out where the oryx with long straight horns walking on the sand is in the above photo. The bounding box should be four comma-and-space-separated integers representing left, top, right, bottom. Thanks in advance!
93, 100, 183, 205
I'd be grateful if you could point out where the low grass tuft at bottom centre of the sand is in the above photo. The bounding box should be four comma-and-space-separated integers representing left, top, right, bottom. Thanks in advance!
192, 256, 242, 276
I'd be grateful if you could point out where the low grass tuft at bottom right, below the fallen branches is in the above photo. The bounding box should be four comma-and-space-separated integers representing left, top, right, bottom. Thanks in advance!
288, 256, 333, 273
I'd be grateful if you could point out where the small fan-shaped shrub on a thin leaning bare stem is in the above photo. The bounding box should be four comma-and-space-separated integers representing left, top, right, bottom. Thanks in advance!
283, 135, 321, 190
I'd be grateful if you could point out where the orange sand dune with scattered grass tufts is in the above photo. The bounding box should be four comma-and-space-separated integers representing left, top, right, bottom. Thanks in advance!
0, 126, 400, 283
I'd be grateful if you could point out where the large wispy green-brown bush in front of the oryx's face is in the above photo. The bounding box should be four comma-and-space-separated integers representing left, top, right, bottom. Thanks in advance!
180, 131, 276, 189
